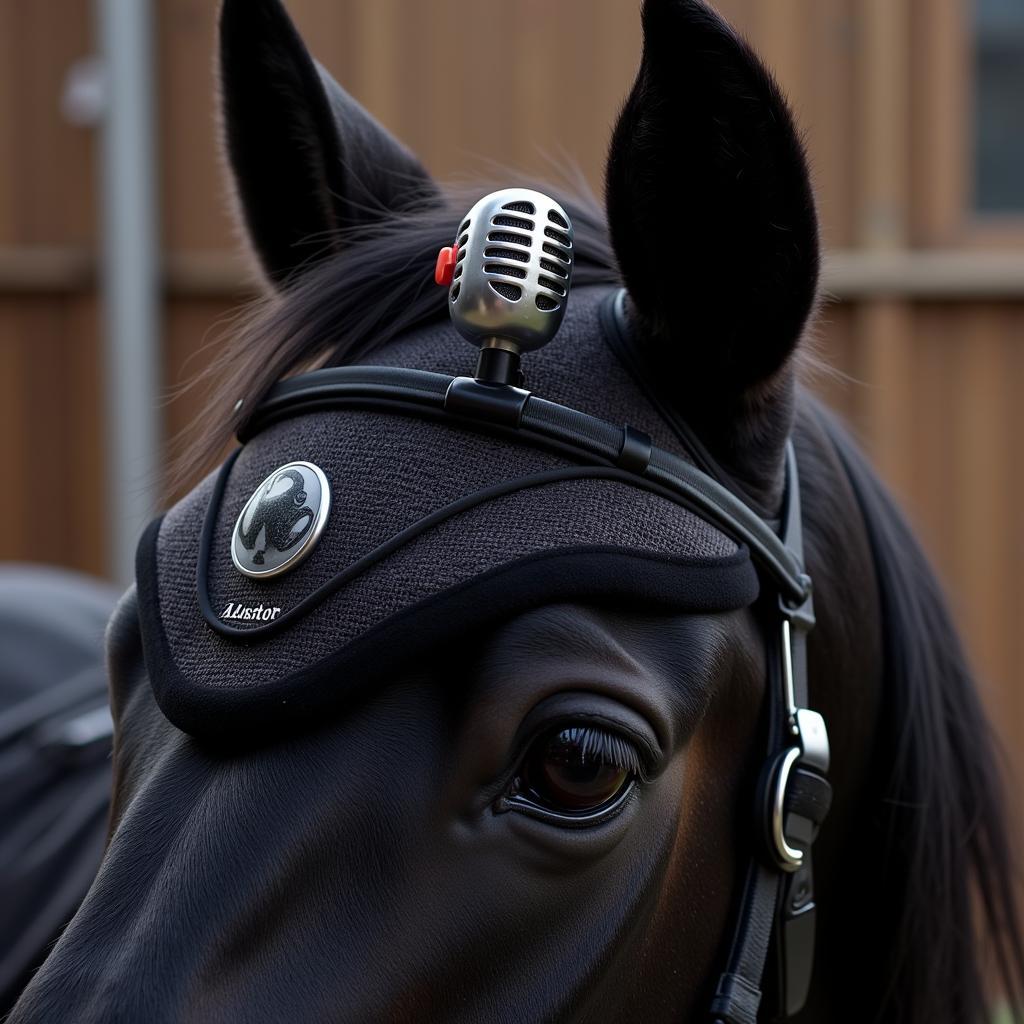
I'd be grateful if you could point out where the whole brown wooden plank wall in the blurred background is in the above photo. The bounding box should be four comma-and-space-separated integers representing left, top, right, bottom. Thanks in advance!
0, 0, 1024, 781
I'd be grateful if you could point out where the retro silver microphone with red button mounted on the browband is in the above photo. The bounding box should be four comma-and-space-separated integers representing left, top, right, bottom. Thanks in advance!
434, 188, 573, 384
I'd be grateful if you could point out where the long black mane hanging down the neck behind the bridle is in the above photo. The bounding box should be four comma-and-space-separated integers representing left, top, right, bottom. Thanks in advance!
819, 413, 1024, 1024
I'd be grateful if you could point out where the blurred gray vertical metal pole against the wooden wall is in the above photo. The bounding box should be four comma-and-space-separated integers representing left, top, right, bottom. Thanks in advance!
96, 0, 161, 584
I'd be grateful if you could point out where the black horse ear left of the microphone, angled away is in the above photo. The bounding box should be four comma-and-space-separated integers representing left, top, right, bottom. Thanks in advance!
220, 0, 437, 287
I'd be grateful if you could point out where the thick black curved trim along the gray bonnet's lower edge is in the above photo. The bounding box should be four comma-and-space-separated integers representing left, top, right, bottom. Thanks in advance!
135, 519, 759, 743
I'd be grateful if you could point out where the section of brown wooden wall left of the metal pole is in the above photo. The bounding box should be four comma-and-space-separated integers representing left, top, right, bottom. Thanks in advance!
0, 0, 103, 572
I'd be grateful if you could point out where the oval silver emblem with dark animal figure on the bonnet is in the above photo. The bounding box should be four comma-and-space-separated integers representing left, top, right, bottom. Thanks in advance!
231, 462, 331, 580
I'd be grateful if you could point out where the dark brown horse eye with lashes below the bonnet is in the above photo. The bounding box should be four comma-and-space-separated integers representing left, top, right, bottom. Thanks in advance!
513, 725, 640, 815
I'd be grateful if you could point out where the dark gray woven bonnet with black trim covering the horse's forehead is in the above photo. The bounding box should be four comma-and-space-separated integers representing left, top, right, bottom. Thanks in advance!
137, 289, 758, 736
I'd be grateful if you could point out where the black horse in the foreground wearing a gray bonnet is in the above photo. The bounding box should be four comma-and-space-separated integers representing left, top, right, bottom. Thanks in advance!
10, 0, 1024, 1024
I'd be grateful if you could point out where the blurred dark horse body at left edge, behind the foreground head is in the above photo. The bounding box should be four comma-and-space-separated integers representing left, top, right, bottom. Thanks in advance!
0, 563, 119, 1015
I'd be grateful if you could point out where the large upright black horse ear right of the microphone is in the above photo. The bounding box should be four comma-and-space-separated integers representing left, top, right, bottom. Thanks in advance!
606, 0, 818, 419
